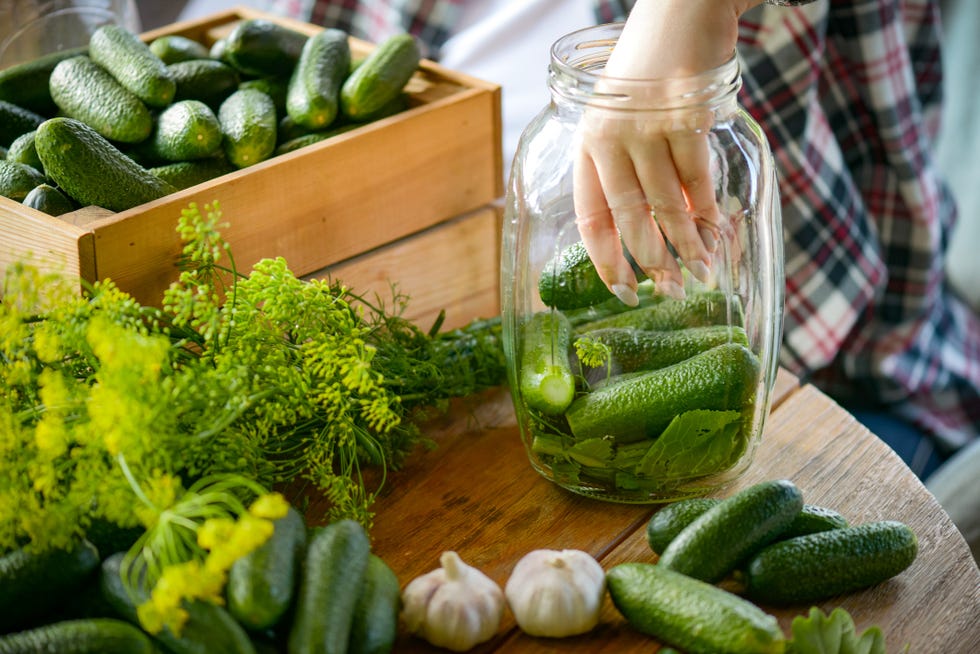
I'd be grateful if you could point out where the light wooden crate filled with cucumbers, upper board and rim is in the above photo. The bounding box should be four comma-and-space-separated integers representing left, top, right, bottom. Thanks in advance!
0, 8, 503, 304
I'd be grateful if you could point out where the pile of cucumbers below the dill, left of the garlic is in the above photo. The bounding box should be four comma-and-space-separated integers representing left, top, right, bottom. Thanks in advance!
0, 509, 401, 654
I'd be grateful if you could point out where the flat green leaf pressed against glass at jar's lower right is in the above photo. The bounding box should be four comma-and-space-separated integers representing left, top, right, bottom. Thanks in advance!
636, 409, 743, 479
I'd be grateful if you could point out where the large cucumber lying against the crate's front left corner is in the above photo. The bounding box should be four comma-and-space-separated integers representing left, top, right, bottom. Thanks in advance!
35, 118, 176, 211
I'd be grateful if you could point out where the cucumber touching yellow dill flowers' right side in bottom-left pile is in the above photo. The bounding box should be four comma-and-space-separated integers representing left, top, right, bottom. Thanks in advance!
226, 507, 306, 631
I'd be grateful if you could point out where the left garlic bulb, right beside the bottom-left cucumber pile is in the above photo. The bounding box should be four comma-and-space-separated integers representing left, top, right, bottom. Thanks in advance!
401, 551, 505, 652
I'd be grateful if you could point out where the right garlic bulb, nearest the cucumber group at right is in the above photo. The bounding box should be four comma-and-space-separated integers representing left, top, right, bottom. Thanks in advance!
504, 550, 606, 638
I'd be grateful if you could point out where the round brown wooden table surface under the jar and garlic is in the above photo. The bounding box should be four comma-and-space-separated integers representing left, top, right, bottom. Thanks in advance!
311, 372, 980, 654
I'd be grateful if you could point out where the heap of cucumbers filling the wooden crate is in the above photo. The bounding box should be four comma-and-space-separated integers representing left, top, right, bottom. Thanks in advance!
0, 18, 421, 215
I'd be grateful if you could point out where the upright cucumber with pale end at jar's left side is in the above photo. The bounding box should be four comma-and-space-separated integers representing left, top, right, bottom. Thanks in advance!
518, 311, 575, 415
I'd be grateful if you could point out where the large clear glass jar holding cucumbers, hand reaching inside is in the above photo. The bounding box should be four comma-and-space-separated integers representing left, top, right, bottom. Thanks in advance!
501, 24, 783, 503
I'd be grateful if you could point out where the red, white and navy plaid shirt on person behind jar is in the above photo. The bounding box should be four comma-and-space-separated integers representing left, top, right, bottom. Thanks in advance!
260, 0, 980, 452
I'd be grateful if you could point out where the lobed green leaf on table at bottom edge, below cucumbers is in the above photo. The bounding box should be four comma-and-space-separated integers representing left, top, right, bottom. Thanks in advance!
786, 606, 885, 654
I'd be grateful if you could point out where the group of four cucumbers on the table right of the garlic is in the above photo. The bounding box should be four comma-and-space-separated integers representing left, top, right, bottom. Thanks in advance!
606, 479, 918, 654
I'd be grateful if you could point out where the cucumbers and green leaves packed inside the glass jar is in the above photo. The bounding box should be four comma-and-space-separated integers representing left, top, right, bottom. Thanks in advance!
516, 242, 762, 498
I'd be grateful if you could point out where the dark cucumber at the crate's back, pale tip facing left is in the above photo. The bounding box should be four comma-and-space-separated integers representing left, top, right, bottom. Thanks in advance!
224, 18, 308, 77
